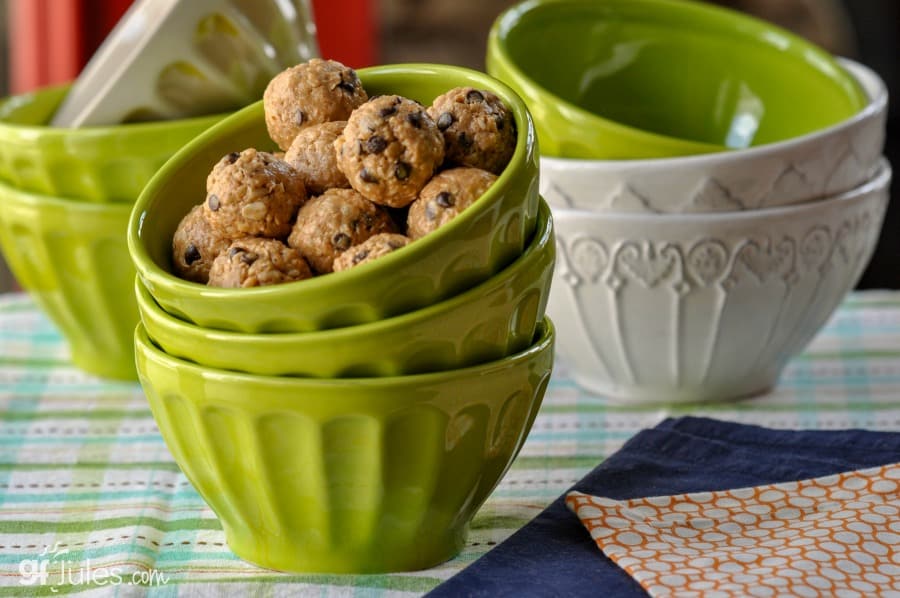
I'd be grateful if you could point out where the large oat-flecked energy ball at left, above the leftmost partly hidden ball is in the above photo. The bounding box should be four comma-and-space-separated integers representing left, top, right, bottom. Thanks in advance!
203, 148, 306, 239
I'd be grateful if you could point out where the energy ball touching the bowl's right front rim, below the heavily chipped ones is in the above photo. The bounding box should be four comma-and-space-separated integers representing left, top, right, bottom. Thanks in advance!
406, 168, 497, 239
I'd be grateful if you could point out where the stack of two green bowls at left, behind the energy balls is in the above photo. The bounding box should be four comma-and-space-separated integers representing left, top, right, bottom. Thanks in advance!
0, 86, 221, 379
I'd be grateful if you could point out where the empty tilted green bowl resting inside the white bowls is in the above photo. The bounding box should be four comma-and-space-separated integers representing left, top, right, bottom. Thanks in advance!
487, 0, 866, 159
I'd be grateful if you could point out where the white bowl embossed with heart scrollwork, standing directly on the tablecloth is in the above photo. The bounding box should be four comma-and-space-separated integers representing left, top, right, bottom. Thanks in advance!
548, 161, 891, 403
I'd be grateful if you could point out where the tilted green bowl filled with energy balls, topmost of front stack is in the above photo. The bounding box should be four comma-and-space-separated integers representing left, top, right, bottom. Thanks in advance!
128, 64, 539, 332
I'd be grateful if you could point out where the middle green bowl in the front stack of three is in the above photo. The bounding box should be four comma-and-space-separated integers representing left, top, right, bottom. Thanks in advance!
135, 204, 556, 378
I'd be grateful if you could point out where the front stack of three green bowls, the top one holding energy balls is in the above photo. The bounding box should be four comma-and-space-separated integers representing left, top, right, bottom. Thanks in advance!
128, 64, 555, 573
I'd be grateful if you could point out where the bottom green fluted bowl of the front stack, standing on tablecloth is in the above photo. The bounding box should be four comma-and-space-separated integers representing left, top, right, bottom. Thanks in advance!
135, 320, 554, 573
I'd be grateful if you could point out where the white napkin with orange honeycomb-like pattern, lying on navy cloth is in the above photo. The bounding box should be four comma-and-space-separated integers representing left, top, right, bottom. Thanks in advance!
566, 463, 900, 598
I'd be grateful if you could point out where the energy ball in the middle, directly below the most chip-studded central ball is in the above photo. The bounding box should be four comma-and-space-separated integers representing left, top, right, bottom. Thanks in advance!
288, 189, 397, 274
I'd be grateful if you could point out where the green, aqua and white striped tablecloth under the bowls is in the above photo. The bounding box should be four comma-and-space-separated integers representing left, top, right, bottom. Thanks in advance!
0, 292, 900, 596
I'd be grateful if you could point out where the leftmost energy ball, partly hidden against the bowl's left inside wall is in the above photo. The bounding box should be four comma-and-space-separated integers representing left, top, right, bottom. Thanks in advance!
172, 206, 231, 284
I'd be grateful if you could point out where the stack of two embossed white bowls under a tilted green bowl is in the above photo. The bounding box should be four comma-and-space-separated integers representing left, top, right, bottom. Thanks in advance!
541, 60, 891, 402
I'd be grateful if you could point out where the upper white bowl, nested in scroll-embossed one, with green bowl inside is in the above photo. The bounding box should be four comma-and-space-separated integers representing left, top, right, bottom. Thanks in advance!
541, 59, 888, 213
